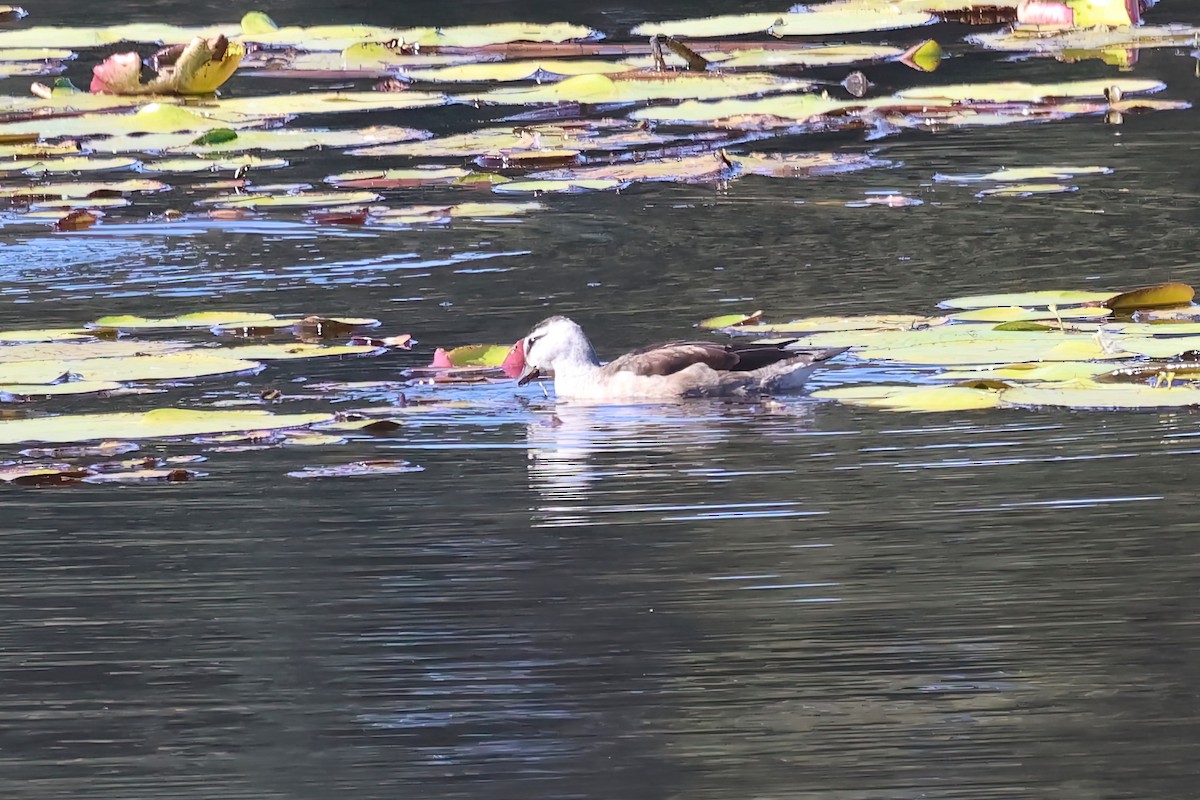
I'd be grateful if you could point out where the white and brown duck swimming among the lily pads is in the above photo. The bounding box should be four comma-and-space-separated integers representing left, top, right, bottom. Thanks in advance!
509, 315, 850, 402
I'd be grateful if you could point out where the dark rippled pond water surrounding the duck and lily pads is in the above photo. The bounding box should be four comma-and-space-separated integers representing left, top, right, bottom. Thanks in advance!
0, 0, 1200, 800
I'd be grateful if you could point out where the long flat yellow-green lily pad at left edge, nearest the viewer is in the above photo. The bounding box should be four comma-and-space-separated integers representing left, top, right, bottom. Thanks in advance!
0, 408, 334, 445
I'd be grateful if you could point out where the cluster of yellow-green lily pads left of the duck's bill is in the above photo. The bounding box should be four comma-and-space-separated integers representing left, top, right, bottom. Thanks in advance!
0, 312, 525, 486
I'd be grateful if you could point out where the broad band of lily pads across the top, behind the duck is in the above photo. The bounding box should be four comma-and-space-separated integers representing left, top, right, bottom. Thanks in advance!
0, 0, 1196, 231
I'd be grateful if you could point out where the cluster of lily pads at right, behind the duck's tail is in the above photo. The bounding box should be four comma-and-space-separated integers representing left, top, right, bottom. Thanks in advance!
702, 283, 1200, 411
